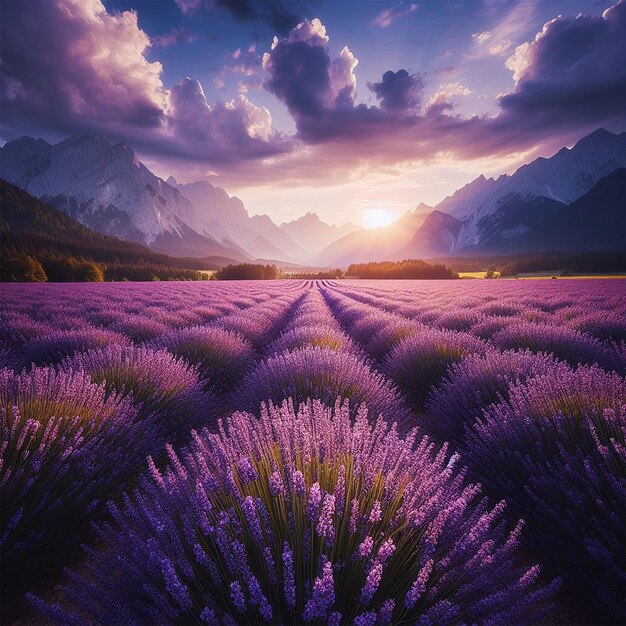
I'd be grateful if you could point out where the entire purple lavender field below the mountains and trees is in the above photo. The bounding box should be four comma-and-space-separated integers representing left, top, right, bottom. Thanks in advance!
0, 280, 626, 626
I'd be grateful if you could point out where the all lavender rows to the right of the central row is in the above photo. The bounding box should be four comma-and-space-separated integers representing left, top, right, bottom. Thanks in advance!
324, 281, 626, 623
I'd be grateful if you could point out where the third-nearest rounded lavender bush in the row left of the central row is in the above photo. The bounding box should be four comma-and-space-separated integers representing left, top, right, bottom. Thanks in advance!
149, 326, 255, 388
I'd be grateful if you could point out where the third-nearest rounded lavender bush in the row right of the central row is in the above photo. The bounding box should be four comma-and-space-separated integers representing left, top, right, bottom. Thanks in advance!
382, 327, 487, 408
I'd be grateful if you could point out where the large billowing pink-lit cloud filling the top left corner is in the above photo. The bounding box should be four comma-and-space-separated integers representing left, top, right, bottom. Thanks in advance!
1, 0, 167, 131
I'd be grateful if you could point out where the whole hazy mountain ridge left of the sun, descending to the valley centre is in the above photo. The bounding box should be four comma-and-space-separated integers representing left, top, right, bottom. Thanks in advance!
0, 134, 352, 263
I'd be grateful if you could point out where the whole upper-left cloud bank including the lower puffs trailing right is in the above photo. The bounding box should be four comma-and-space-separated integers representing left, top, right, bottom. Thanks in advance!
0, 0, 291, 167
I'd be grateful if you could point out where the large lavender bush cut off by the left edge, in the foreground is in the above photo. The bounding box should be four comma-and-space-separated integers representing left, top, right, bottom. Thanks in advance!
0, 368, 143, 616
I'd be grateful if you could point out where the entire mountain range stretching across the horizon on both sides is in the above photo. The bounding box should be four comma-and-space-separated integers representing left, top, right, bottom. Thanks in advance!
0, 129, 626, 267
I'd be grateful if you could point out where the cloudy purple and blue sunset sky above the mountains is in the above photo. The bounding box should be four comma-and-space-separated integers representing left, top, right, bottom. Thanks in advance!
0, 0, 626, 225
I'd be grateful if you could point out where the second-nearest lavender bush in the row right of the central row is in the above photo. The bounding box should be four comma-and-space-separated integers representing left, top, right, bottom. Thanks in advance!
424, 350, 569, 444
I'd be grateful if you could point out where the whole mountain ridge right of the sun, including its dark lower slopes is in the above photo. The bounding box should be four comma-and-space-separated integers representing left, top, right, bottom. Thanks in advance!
319, 129, 626, 266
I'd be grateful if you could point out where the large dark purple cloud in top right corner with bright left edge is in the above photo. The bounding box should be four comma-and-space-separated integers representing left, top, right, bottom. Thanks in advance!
499, 0, 626, 127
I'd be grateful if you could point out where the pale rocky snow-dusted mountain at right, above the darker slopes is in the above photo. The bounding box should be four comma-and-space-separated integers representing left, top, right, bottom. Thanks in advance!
436, 128, 626, 251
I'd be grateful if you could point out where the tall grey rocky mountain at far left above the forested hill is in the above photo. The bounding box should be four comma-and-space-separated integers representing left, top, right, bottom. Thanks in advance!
0, 134, 250, 259
